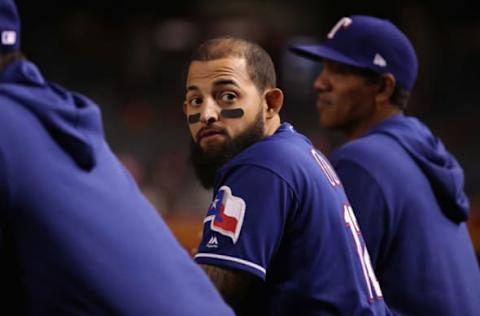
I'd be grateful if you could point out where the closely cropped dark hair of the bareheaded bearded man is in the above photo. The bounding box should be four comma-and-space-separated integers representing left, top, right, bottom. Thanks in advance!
191, 36, 277, 91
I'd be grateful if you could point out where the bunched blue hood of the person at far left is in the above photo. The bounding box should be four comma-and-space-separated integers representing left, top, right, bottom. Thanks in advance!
0, 60, 104, 170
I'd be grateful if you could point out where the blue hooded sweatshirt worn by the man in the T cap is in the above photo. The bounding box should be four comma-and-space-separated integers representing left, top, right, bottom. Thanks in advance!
331, 116, 480, 316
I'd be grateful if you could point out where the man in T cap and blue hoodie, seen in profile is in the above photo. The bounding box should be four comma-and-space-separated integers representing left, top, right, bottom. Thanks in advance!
291, 15, 480, 316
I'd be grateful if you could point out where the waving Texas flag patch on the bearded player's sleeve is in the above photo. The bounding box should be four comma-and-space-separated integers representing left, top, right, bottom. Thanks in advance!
203, 185, 245, 243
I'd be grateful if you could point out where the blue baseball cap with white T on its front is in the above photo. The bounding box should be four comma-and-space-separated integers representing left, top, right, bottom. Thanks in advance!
290, 15, 418, 91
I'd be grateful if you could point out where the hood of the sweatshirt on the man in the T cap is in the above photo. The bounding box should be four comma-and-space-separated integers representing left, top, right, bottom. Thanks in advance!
367, 115, 469, 223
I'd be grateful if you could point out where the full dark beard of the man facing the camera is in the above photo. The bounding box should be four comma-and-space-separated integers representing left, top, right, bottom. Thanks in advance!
190, 111, 265, 189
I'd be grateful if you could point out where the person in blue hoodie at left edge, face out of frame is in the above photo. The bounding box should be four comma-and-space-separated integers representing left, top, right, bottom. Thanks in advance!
0, 0, 233, 315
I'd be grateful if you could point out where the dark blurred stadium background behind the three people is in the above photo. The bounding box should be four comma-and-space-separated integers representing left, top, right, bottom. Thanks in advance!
17, 0, 480, 260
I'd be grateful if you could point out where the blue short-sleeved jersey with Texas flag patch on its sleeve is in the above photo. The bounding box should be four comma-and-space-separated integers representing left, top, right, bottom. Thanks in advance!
195, 123, 386, 315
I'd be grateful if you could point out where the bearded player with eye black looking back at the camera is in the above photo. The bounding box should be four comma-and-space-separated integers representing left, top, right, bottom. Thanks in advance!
184, 37, 389, 316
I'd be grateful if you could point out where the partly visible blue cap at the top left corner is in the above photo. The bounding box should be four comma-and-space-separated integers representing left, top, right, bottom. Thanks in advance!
0, 0, 20, 54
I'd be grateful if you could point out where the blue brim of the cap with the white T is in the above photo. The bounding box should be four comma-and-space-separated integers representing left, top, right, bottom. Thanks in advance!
290, 45, 364, 67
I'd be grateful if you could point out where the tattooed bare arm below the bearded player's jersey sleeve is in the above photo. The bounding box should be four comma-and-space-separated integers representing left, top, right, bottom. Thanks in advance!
200, 264, 258, 308
